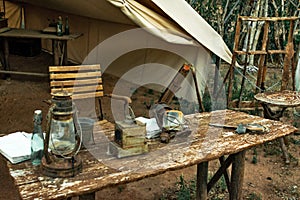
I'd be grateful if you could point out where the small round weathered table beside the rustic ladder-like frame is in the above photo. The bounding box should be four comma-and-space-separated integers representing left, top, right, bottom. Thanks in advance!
254, 90, 300, 164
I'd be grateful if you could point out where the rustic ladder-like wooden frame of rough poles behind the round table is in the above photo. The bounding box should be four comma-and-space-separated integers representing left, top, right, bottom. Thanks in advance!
223, 16, 299, 108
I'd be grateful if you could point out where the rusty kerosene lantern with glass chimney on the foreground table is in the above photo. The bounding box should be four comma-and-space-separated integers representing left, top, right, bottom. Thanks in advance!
42, 90, 82, 177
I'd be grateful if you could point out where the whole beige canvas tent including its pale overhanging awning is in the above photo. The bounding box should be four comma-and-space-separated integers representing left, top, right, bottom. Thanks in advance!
6, 0, 231, 111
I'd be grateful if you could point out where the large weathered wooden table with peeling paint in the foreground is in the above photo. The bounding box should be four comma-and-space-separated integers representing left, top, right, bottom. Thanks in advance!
8, 110, 297, 200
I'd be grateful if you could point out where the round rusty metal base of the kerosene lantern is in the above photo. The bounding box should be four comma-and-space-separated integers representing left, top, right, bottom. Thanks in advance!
41, 156, 82, 178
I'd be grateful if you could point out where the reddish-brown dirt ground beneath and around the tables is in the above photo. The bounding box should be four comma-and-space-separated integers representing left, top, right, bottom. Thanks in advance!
0, 53, 300, 200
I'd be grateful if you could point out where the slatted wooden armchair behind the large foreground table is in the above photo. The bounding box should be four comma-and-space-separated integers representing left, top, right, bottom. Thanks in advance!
49, 64, 131, 144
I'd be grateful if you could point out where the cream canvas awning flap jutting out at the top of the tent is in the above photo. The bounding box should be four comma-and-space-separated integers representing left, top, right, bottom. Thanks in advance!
108, 0, 232, 63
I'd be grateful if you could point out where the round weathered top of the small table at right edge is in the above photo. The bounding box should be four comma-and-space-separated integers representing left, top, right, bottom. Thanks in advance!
254, 90, 300, 107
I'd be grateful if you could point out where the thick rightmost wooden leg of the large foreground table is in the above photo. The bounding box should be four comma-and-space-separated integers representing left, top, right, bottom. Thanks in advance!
229, 150, 246, 200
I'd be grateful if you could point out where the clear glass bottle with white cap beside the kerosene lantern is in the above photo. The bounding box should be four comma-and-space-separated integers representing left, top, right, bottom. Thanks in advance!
31, 110, 44, 166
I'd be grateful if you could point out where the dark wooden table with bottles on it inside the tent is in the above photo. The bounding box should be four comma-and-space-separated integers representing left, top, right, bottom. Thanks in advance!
0, 28, 82, 76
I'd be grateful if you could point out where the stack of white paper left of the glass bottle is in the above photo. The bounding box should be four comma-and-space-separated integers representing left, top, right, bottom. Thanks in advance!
0, 132, 32, 164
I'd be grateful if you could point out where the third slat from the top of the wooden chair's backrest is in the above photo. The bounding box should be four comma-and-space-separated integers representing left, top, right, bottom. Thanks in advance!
50, 78, 102, 87
